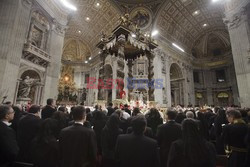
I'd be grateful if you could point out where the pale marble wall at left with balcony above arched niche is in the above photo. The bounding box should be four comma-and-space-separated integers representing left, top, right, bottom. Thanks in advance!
0, 0, 67, 104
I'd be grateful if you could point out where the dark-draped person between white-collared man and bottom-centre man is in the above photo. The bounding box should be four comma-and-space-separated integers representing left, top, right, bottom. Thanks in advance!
101, 114, 123, 167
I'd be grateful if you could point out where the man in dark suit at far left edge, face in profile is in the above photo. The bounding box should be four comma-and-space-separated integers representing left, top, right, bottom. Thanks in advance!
0, 105, 19, 167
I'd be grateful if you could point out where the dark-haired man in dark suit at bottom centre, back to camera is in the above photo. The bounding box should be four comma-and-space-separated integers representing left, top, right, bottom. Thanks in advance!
115, 115, 160, 167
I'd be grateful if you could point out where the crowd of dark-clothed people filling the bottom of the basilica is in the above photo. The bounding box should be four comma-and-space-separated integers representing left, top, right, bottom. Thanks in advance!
0, 99, 250, 167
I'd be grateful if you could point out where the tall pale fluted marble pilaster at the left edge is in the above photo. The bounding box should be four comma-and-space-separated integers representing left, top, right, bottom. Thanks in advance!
0, 0, 32, 102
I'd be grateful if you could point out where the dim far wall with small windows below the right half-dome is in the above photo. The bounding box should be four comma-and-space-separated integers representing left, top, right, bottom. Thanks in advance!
195, 63, 239, 106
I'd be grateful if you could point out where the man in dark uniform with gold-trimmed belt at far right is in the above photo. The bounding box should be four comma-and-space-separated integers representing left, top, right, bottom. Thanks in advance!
222, 110, 248, 167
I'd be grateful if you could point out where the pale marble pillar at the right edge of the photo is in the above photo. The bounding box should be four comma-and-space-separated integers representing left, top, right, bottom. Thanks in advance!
224, 0, 250, 107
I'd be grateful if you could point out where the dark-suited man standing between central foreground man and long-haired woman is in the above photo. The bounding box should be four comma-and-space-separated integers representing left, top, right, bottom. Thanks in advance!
156, 109, 182, 167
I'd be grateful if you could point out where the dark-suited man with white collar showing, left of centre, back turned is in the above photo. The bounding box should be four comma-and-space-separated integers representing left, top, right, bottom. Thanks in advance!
59, 106, 97, 167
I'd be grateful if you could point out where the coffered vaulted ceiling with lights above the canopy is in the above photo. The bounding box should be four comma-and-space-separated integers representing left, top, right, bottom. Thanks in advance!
66, 0, 229, 58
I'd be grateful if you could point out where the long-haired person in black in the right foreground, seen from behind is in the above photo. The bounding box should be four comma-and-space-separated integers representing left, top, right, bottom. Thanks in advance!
168, 118, 216, 167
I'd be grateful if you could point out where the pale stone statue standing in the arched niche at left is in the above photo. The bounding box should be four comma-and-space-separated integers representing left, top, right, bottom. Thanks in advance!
18, 76, 39, 98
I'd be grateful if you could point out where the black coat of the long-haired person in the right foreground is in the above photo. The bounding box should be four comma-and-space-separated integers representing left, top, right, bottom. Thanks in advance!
168, 140, 216, 167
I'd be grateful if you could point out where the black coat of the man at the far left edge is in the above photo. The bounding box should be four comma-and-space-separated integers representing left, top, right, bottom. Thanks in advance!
0, 121, 19, 167
